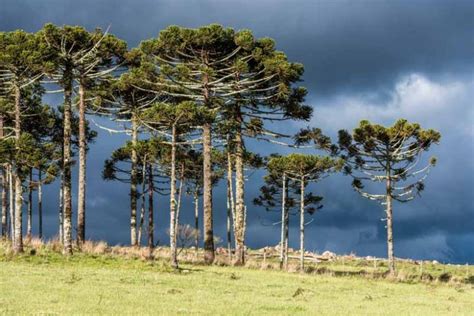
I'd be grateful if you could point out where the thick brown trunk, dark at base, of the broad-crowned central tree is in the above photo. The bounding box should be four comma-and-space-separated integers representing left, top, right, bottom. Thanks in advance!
202, 123, 214, 264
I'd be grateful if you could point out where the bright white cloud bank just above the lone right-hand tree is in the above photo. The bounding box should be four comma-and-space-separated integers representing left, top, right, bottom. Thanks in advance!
312, 73, 474, 137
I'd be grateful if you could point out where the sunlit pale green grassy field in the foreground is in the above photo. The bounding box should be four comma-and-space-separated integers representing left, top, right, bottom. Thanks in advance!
0, 242, 474, 315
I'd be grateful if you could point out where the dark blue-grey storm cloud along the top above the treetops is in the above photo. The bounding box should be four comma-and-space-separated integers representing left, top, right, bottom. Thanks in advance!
0, 0, 474, 96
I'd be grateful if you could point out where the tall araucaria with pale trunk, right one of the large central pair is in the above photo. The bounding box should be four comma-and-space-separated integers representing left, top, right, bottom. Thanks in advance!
218, 30, 312, 264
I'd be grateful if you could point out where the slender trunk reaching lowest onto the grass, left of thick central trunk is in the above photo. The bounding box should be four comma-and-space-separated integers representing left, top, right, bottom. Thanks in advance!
170, 124, 178, 268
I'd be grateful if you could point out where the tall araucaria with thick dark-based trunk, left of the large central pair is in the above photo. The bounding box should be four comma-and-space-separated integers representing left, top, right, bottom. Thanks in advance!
136, 25, 241, 263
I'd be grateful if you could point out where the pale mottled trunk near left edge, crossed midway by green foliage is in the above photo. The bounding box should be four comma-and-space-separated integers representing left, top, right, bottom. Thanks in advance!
13, 87, 23, 254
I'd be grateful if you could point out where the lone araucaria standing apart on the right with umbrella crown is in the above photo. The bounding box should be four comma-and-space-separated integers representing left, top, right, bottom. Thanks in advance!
336, 119, 441, 274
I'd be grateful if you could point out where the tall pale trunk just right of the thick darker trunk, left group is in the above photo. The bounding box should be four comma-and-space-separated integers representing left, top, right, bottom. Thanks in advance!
77, 79, 87, 247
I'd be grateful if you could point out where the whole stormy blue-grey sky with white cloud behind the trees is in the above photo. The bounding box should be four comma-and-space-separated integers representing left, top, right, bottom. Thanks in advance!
0, 0, 474, 263
